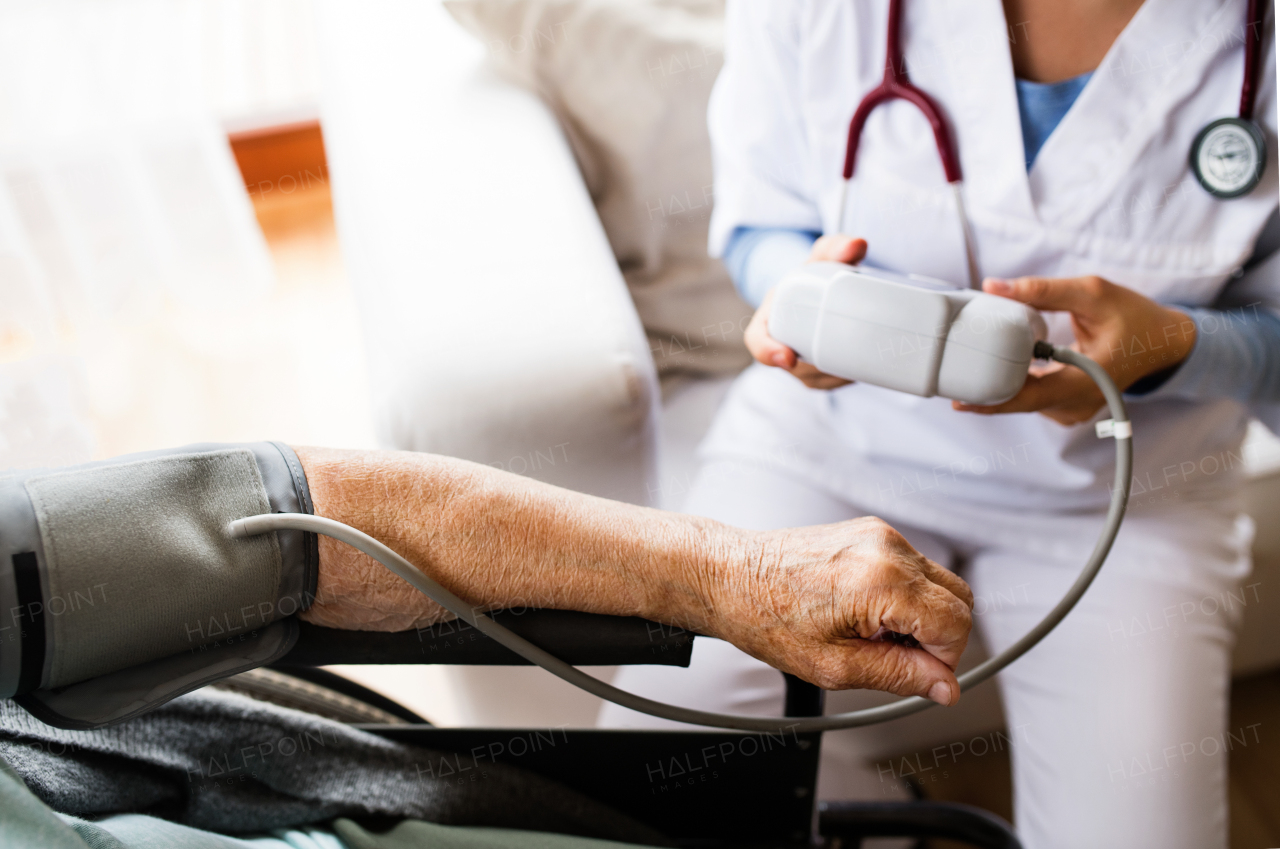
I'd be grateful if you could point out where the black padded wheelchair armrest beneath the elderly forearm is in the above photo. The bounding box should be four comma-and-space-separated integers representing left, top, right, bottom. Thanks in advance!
280, 610, 694, 667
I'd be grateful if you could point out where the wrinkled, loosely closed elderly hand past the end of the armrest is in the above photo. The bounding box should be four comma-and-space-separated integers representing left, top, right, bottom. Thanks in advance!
705, 517, 973, 706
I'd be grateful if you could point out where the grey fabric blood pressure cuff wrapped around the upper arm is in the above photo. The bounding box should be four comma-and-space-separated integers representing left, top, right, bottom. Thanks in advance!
0, 442, 319, 729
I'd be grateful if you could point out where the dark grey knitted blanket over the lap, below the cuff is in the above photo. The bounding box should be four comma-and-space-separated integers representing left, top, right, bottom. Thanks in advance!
0, 689, 668, 845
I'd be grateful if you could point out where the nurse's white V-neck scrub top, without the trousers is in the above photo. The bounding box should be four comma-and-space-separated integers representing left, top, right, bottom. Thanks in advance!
707, 0, 1280, 512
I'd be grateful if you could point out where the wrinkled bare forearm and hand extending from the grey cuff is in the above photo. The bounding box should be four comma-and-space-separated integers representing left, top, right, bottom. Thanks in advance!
296, 448, 973, 704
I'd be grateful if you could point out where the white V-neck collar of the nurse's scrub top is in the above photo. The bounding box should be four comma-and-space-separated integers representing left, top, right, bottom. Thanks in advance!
926, 0, 1244, 229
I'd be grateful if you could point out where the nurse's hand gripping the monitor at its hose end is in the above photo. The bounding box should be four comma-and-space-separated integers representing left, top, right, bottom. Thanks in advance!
951, 277, 1196, 425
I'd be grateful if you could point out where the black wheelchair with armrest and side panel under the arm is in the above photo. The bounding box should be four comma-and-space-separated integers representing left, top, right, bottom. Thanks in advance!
223, 610, 1021, 849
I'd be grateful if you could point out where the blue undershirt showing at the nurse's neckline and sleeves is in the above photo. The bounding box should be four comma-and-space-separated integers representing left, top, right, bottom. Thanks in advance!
724, 72, 1280, 403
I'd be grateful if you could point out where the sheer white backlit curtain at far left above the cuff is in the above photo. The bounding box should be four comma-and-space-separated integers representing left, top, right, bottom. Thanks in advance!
0, 0, 335, 469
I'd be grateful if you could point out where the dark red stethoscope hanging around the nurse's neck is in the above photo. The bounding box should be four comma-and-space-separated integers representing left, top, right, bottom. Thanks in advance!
836, 0, 1267, 288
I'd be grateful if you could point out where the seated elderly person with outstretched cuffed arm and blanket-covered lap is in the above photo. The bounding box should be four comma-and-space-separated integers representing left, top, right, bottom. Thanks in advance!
0, 443, 973, 849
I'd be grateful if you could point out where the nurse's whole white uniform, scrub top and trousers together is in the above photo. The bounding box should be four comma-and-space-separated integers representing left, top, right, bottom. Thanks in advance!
602, 0, 1280, 849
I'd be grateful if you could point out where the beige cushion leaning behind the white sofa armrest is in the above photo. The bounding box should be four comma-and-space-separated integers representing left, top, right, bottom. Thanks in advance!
444, 0, 751, 374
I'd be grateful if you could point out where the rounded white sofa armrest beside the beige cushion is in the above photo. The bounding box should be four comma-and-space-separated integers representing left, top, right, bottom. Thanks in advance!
320, 0, 659, 503
